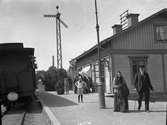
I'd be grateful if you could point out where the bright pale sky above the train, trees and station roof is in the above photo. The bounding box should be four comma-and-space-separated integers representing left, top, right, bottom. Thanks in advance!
0, 0, 167, 70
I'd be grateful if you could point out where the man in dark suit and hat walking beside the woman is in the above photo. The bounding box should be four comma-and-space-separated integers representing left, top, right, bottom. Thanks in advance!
134, 67, 153, 112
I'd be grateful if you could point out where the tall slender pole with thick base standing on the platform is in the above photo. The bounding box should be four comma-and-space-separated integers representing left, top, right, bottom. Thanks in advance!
95, 0, 105, 108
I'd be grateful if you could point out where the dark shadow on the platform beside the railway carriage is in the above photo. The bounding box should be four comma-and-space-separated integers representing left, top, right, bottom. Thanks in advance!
40, 92, 78, 107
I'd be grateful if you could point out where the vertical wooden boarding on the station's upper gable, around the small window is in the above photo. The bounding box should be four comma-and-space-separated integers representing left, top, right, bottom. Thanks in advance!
111, 18, 167, 49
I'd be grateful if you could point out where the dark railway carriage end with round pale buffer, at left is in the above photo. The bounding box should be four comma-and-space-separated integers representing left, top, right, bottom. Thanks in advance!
0, 43, 35, 105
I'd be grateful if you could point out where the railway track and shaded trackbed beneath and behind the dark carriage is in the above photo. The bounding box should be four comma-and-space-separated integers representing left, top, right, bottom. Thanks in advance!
2, 95, 46, 125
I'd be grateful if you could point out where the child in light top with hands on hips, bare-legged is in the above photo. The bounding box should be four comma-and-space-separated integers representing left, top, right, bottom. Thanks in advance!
75, 75, 86, 103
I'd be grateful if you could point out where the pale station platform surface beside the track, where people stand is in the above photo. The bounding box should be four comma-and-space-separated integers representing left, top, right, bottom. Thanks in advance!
37, 92, 166, 125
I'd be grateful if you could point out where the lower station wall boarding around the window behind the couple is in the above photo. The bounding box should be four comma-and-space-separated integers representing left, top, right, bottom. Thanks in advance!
114, 54, 164, 92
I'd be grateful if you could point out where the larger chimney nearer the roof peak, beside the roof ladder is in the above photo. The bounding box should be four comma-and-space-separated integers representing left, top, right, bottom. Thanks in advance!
127, 13, 139, 27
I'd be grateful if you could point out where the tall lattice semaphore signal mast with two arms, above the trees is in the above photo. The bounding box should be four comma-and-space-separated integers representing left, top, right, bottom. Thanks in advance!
44, 6, 68, 68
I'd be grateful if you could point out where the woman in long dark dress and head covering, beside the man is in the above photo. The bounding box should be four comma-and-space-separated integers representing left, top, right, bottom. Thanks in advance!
113, 71, 129, 112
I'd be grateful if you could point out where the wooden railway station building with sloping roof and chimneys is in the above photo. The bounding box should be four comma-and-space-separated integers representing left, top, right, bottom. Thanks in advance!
70, 8, 167, 94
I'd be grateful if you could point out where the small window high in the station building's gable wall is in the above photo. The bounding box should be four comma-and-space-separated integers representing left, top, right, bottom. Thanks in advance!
156, 25, 167, 41
